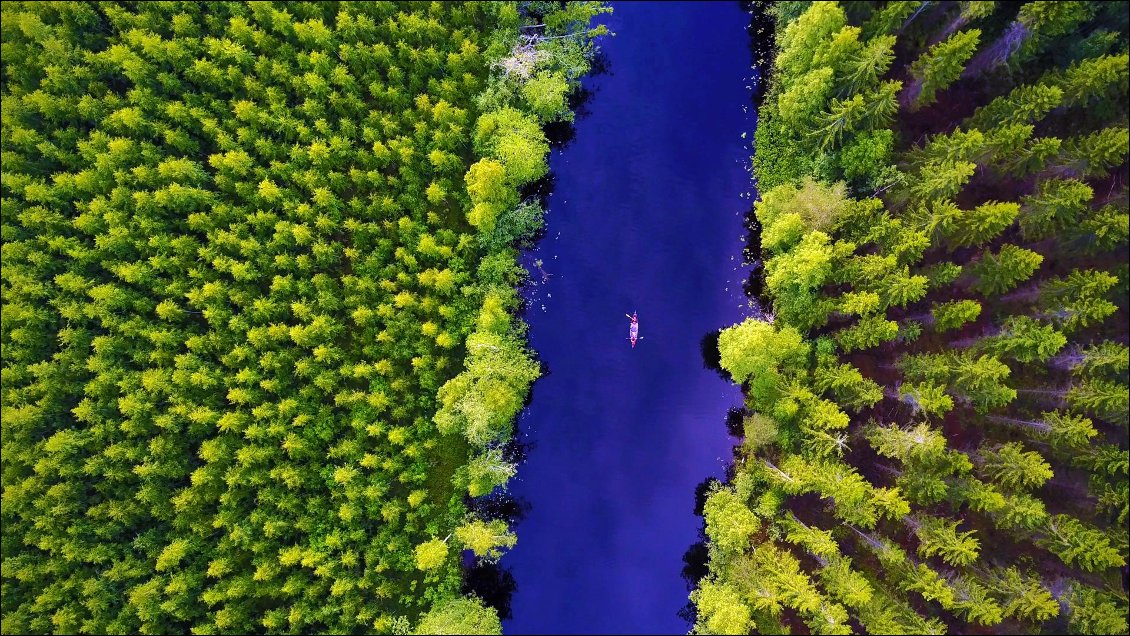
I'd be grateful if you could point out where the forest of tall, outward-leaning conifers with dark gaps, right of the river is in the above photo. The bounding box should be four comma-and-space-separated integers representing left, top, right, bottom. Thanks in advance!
685, 1, 1130, 634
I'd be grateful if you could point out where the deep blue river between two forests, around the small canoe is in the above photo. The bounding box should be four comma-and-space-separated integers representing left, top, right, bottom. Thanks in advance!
503, 2, 755, 634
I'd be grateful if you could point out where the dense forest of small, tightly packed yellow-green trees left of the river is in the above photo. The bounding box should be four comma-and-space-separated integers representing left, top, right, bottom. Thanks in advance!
0, 2, 611, 634
